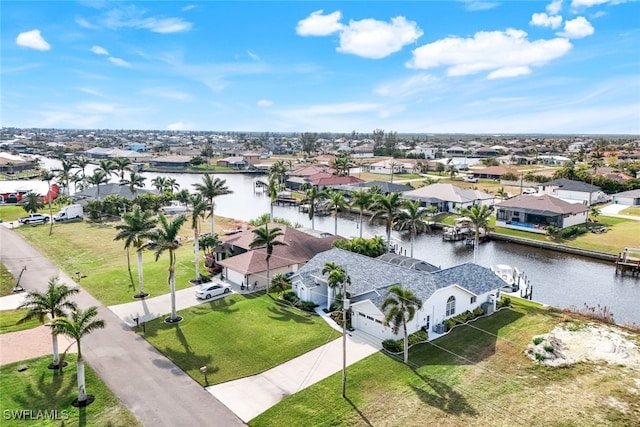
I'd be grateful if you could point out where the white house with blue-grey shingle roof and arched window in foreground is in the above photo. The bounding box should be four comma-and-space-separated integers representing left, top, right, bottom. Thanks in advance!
292, 248, 504, 340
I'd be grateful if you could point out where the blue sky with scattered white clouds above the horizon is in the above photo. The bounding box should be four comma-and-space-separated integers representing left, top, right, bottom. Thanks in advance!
0, 0, 640, 134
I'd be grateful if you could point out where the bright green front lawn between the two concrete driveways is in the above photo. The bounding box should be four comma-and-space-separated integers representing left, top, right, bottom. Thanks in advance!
139, 294, 340, 384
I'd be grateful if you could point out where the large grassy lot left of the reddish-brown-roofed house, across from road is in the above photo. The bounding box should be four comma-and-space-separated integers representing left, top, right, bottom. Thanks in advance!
16, 218, 239, 305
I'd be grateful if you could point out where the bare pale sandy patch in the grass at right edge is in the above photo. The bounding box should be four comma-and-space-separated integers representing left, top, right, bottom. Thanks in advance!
526, 323, 640, 369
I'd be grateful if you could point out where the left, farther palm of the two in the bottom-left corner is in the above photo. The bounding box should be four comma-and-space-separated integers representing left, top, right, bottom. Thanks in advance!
18, 276, 80, 369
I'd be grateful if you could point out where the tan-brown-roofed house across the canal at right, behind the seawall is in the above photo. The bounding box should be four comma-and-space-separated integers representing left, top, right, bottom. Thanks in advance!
495, 194, 590, 234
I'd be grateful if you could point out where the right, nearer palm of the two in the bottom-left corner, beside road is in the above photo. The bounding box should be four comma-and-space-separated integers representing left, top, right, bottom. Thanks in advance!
51, 307, 104, 407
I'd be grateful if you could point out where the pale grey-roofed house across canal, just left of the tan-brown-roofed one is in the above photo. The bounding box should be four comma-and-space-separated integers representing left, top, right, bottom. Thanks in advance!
401, 184, 495, 213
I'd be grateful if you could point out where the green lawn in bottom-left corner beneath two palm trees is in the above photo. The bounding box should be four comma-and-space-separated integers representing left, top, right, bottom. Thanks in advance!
0, 354, 140, 427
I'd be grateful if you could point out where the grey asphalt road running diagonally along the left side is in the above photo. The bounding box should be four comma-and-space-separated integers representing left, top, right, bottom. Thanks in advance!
0, 226, 244, 427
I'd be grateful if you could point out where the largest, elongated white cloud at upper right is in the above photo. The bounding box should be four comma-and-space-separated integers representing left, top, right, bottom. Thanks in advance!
406, 29, 572, 78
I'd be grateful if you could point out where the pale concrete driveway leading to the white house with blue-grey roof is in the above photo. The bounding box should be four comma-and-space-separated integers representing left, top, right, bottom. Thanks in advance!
207, 334, 380, 422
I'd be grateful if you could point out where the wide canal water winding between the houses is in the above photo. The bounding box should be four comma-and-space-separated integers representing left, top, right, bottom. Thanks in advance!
43, 159, 640, 324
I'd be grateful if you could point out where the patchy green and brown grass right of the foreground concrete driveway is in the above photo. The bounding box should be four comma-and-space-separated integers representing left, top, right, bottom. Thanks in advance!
249, 300, 640, 426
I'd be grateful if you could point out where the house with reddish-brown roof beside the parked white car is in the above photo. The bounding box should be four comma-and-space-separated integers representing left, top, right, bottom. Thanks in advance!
216, 224, 340, 287
